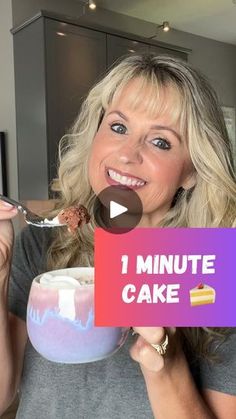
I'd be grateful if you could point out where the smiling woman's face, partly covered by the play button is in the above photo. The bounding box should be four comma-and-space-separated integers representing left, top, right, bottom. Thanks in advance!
89, 80, 194, 226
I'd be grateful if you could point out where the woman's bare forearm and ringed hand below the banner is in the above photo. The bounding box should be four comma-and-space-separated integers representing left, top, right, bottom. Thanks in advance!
130, 327, 219, 419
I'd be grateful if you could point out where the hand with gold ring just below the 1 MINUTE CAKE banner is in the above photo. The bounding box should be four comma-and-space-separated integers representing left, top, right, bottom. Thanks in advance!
130, 327, 179, 373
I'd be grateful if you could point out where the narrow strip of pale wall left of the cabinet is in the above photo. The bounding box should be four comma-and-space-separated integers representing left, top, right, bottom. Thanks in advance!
0, 0, 18, 199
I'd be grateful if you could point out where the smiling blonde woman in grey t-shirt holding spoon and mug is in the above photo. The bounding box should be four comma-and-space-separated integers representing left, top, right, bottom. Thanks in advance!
0, 55, 236, 419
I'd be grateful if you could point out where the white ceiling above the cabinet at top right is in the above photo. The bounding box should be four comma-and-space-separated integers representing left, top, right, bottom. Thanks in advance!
95, 0, 236, 45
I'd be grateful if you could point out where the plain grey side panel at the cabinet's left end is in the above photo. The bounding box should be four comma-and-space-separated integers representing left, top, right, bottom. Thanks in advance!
14, 19, 48, 200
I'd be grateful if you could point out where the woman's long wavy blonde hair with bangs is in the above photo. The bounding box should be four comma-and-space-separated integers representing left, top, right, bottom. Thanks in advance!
47, 54, 236, 355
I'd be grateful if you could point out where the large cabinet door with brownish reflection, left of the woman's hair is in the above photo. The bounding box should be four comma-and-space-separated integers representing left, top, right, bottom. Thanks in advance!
45, 19, 106, 181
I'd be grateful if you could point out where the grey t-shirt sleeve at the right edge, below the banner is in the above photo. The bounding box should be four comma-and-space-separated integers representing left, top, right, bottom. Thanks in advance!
199, 328, 236, 395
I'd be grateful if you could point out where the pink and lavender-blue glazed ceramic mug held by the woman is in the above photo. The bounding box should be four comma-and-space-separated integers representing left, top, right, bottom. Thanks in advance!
27, 267, 128, 364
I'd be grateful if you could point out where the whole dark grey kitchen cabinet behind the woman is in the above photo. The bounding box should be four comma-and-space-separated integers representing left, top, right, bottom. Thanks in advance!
12, 12, 189, 200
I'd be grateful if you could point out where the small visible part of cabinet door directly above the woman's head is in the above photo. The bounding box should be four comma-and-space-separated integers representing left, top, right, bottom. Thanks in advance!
107, 35, 149, 67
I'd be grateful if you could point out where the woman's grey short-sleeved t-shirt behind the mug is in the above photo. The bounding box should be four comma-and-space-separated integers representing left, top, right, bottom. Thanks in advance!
9, 226, 236, 419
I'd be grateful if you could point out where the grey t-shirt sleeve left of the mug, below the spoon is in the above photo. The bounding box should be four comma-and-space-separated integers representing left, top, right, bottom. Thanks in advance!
8, 226, 48, 321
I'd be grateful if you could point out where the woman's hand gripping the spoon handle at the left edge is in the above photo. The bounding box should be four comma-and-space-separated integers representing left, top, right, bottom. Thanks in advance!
0, 200, 18, 276
